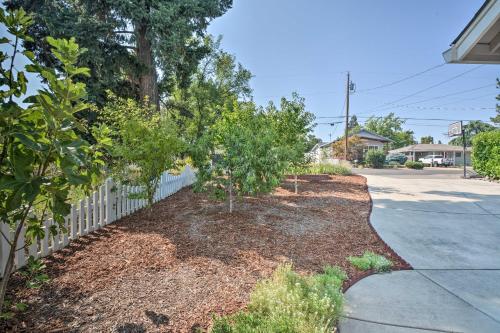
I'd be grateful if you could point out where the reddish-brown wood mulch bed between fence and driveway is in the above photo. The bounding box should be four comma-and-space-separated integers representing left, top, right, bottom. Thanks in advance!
0, 175, 409, 333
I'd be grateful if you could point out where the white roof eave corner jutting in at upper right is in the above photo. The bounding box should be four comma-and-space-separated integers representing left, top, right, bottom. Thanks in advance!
443, 0, 500, 64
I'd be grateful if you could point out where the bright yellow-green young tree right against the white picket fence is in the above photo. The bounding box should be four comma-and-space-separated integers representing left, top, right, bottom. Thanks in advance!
99, 94, 184, 213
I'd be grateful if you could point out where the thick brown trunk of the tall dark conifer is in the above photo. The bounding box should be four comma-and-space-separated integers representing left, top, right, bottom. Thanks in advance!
136, 24, 160, 109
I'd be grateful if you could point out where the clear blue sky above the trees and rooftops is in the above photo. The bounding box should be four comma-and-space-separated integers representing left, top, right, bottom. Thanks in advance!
209, 0, 500, 142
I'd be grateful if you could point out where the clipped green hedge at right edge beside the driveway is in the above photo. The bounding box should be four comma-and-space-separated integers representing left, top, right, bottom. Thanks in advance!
472, 130, 500, 179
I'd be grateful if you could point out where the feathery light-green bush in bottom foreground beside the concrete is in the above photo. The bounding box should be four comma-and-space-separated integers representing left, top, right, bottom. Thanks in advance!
212, 265, 347, 333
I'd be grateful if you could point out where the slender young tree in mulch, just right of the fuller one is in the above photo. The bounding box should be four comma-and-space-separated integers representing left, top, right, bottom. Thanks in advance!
267, 93, 314, 194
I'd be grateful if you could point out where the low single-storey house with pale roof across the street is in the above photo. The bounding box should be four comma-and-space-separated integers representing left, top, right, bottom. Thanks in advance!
389, 143, 471, 165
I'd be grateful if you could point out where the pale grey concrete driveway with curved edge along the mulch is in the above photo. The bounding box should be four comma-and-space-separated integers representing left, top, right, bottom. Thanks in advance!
340, 168, 500, 333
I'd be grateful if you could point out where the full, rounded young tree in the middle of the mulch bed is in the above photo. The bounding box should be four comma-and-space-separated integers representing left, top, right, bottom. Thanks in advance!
192, 99, 287, 213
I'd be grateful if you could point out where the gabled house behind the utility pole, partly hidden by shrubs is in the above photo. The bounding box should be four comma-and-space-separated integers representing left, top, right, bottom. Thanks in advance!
308, 129, 392, 163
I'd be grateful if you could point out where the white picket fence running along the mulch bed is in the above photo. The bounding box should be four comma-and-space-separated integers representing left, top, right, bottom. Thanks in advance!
0, 166, 195, 277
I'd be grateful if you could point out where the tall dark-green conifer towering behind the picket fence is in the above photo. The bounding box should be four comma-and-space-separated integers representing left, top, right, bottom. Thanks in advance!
6, 0, 232, 109
